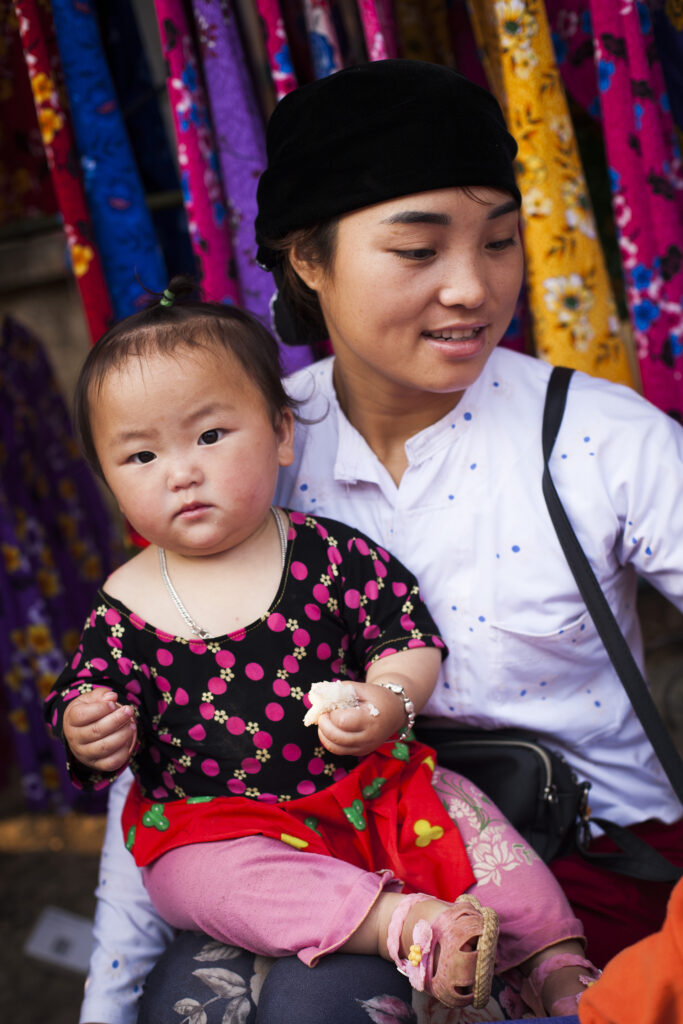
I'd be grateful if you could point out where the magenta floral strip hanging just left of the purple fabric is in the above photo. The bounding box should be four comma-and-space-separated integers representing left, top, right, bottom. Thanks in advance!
155, 0, 242, 303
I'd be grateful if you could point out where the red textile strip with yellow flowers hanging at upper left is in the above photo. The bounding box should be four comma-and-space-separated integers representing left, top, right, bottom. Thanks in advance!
15, 0, 113, 341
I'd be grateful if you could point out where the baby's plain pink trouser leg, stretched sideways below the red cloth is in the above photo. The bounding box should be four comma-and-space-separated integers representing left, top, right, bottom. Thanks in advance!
143, 836, 401, 967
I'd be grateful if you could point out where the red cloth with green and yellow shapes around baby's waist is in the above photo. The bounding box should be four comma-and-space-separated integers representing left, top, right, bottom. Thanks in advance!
122, 740, 474, 902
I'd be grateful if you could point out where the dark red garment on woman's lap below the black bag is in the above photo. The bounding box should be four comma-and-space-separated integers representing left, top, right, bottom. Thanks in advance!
549, 818, 683, 968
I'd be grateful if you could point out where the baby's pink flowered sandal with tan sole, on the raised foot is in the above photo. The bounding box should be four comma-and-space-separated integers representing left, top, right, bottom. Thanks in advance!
387, 893, 498, 1010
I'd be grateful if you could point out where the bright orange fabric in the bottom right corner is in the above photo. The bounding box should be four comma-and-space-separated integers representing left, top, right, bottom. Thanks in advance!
579, 881, 683, 1024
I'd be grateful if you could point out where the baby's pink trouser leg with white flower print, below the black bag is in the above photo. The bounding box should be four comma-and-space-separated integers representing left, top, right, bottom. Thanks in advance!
433, 768, 598, 1012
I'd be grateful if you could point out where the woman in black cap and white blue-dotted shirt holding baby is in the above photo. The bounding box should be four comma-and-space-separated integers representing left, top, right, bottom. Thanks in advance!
77, 61, 683, 1024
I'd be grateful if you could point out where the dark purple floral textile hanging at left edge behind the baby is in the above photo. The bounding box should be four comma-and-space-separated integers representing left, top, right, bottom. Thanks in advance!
0, 317, 116, 810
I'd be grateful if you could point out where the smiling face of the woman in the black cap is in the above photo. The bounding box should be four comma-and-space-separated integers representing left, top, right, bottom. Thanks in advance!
295, 188, 523, 412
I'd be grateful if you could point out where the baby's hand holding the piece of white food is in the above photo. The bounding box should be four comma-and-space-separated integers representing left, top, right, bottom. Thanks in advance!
317, 683, 405, 758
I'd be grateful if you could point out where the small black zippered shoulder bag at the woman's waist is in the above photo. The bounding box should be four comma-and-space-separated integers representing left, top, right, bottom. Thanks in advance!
416, 727, 591, 862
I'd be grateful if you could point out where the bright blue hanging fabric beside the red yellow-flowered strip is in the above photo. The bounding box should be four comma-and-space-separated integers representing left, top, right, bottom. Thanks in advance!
52, 0, 167, 319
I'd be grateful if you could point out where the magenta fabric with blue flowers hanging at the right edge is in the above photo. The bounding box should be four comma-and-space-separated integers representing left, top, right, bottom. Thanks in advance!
591, 0, 683, 420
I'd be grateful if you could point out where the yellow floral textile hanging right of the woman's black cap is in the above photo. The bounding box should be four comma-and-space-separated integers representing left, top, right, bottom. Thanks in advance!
470, 0, 634, 384
